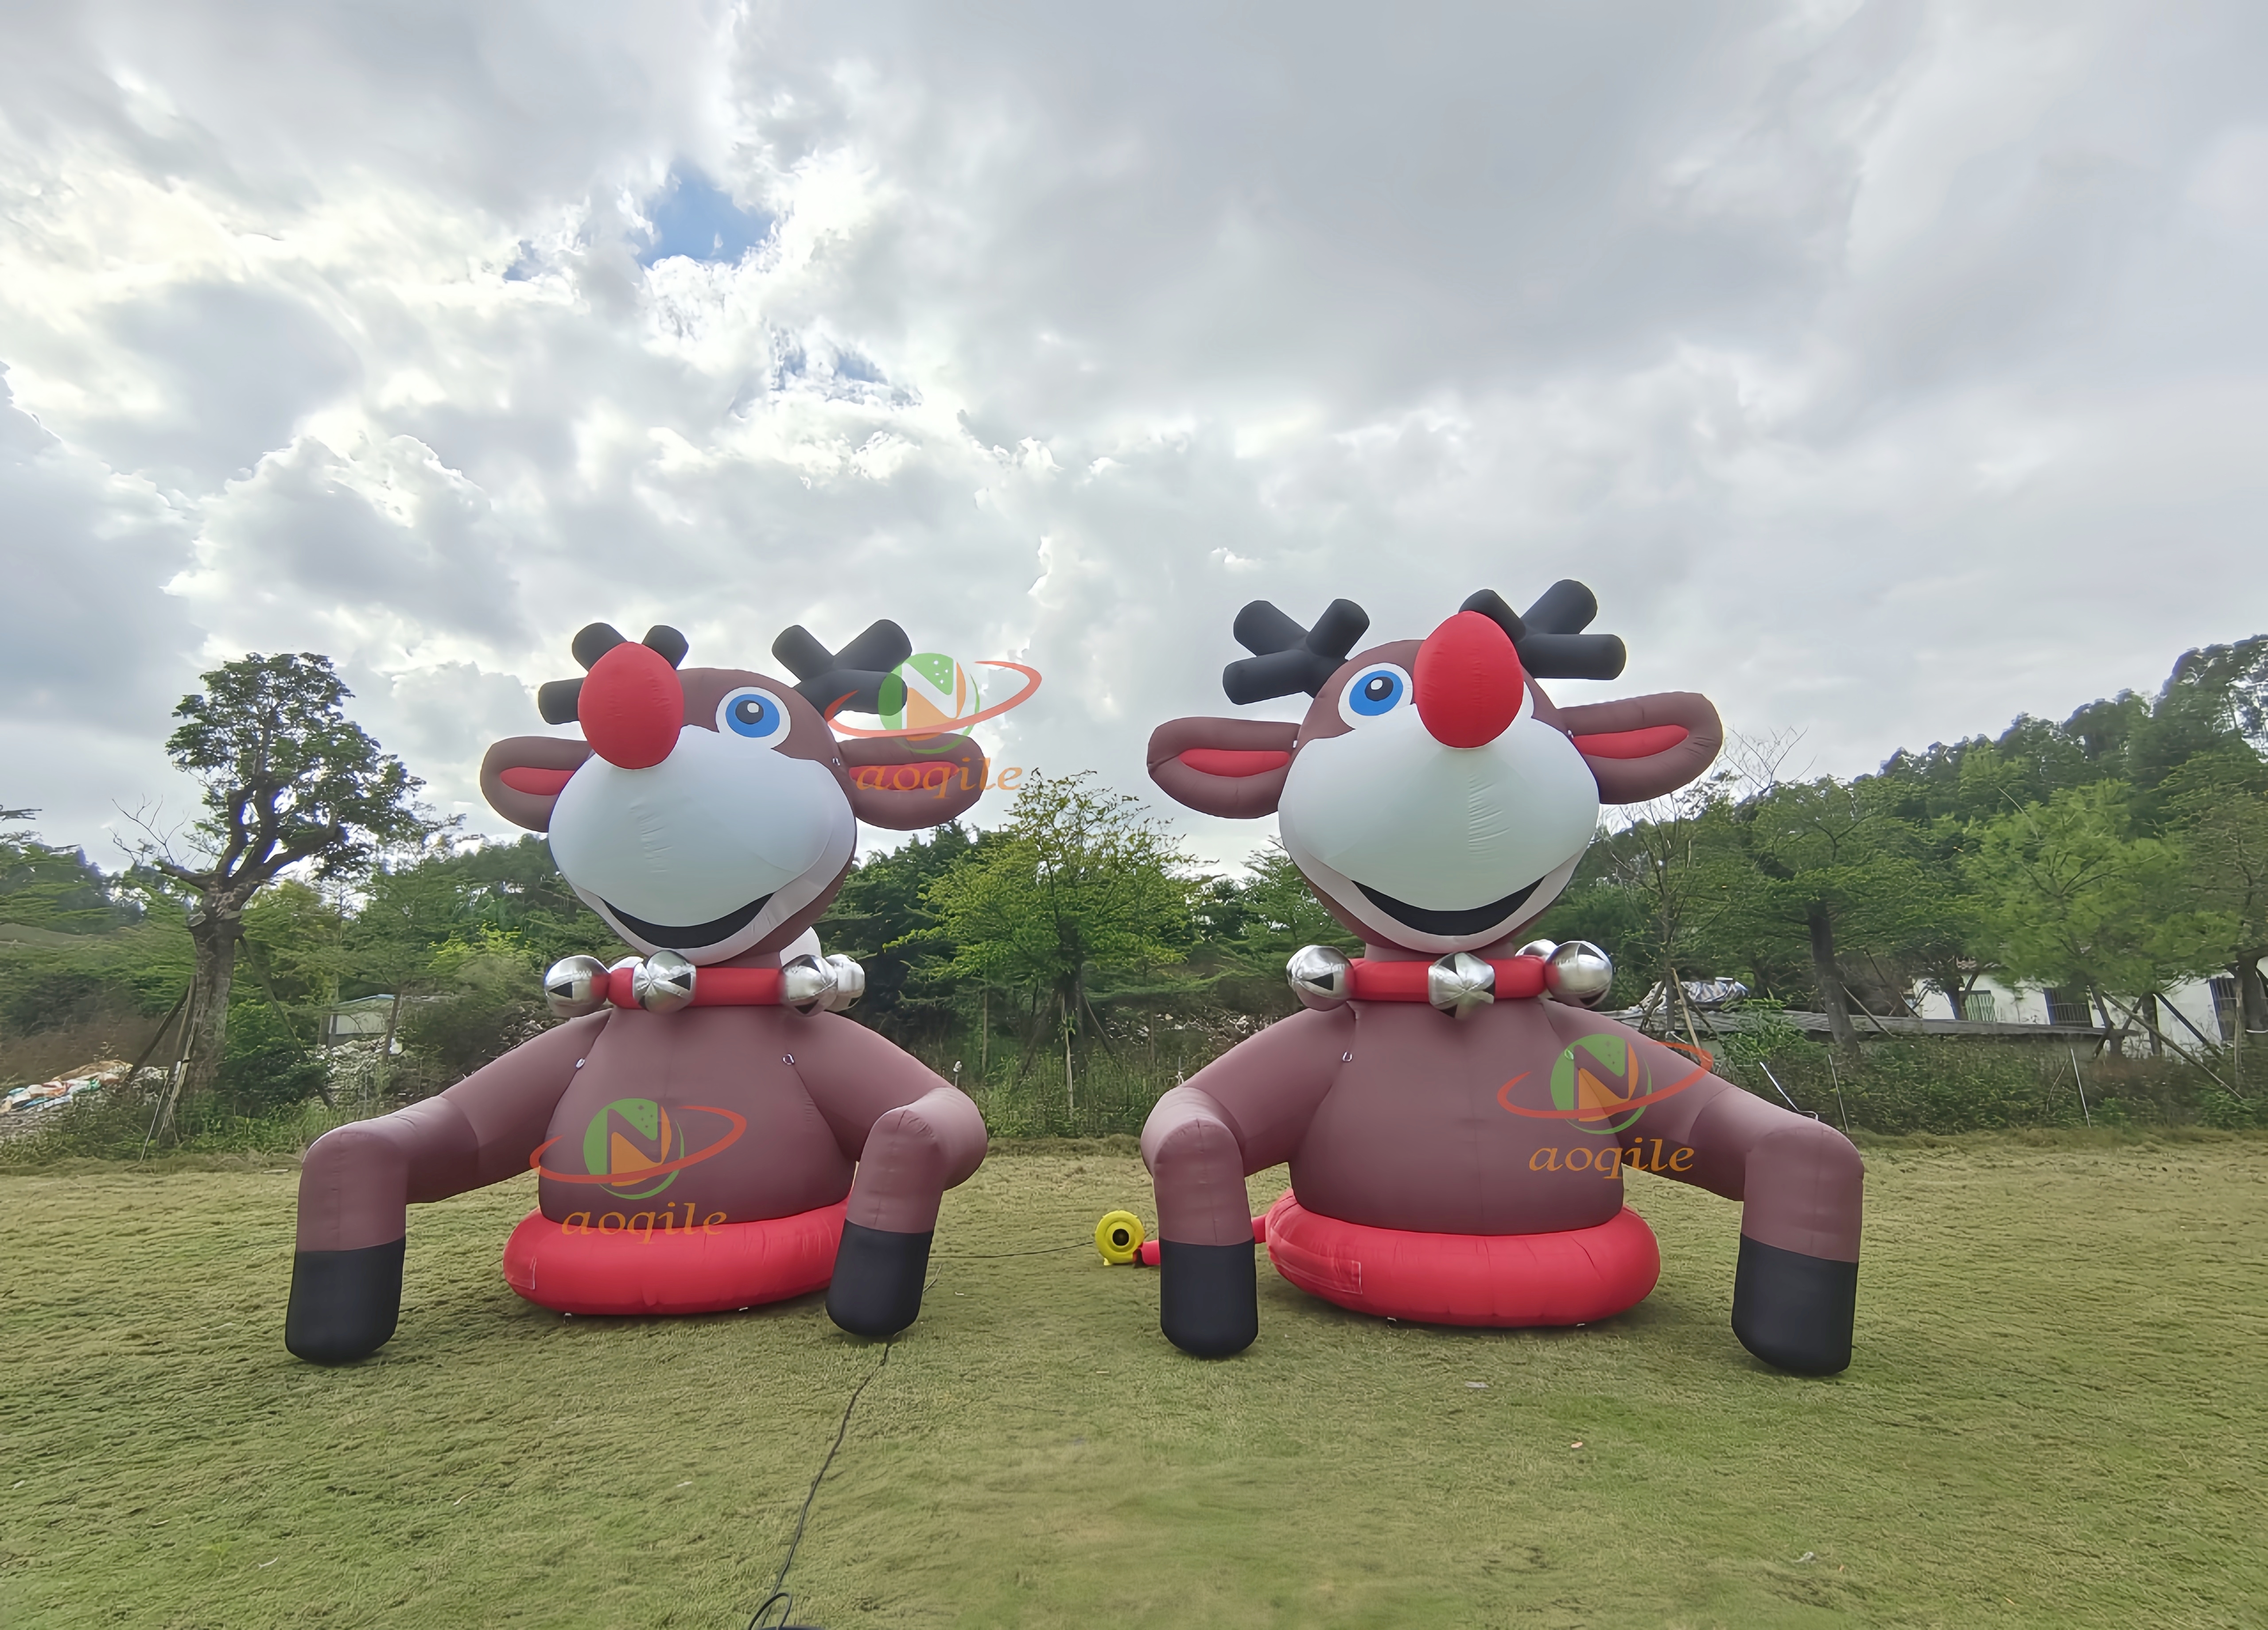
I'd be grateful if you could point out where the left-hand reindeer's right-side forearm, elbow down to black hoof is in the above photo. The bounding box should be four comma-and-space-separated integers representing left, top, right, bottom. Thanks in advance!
828, 1086, 984, 1338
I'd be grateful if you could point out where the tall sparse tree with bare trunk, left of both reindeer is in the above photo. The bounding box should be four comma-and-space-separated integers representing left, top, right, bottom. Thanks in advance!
145, 651, 435, 1131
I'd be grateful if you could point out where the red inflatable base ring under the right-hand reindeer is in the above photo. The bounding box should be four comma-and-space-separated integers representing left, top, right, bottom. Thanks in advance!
1266, 1192, 1662, 1328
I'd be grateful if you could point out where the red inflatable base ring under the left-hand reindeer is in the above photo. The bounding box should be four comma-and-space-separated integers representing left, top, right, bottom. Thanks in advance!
504, 1199, 848, 1315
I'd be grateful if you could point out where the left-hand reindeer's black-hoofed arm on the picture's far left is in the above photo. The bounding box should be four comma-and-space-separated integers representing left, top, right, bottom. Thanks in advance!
284, 1013, 606, 1365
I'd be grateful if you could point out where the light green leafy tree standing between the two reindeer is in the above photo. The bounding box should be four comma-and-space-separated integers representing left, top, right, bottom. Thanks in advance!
909, 771, 1191, 1083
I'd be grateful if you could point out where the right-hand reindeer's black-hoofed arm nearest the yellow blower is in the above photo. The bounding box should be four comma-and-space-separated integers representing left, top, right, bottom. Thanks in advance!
1141, 1009, 1354, 1358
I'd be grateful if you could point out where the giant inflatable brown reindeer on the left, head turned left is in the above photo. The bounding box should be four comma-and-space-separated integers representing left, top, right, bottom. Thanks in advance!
284, 624, 984, 1362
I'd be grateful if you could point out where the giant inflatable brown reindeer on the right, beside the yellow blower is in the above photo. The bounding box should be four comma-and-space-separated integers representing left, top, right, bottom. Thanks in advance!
1143, 582, 1862, 1374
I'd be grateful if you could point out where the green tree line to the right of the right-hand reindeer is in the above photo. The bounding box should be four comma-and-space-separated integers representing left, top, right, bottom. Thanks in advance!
1545, 637, 2268, 1070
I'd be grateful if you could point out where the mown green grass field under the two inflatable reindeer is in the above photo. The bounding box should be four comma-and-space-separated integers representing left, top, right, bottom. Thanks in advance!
0, 1136, 2268, 1630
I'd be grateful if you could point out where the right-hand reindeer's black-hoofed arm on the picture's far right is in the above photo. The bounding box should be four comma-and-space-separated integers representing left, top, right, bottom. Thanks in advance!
1553, 1004, 1867, 1376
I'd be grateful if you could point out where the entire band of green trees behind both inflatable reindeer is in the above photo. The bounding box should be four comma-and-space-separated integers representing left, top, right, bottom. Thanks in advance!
0, 637, 2268, 1147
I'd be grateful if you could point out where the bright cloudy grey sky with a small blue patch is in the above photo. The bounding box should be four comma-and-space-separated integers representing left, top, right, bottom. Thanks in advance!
0, 0, 2268, 875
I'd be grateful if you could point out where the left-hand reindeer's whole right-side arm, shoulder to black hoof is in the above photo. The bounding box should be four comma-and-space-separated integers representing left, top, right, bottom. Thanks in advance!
792, 1013, 984, 1335
